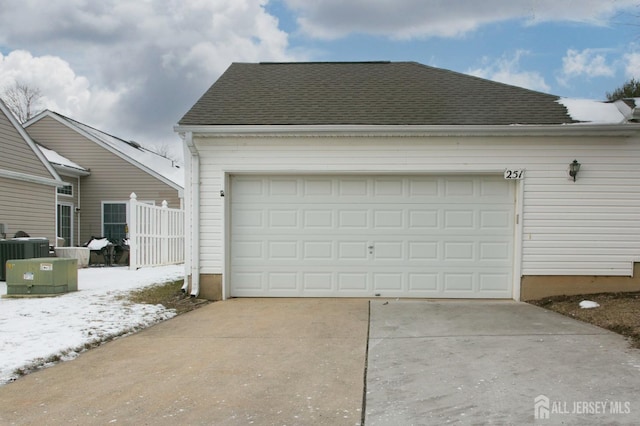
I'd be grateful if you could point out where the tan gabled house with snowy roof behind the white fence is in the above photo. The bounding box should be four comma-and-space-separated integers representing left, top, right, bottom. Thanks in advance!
24, 111, 184, 246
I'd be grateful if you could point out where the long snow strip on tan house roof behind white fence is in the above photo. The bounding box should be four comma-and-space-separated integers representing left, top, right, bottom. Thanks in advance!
61, 116, 184, 188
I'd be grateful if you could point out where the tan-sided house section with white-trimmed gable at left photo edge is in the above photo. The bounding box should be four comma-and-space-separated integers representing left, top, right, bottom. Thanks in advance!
0, 100, 64, 241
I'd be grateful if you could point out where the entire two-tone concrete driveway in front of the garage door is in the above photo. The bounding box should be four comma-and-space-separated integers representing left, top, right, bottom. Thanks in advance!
0, 299, 640, 426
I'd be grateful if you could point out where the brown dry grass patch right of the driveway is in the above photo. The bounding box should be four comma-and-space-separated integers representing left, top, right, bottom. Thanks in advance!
529, 292, 640, 348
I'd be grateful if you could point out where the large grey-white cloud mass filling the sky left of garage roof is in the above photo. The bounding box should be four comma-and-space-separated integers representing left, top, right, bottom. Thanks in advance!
0, 0, 302, 149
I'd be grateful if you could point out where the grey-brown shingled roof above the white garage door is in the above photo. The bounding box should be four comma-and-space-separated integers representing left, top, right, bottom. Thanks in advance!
179, 62, 574, 126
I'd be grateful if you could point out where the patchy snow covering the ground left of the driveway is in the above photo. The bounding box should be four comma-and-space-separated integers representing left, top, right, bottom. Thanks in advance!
0, 265, 184, 386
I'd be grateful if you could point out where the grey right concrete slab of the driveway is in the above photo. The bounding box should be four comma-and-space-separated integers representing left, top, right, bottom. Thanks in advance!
366, 300, 640, 426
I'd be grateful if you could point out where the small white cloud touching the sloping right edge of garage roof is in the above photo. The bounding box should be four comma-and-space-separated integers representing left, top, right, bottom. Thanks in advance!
467, 50, 551, 92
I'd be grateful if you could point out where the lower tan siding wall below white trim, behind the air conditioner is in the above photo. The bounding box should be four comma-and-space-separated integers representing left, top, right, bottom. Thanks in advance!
0, 178, 56, 245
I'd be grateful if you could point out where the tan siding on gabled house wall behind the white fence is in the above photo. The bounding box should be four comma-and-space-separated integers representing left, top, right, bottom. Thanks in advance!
27, 117, 180, 243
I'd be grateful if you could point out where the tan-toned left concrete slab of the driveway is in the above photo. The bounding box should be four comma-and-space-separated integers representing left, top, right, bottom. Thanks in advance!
0, 299, 369, 425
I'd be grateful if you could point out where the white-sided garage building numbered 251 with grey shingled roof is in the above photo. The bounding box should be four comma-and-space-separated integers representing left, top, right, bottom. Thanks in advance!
176, 62, 640, 300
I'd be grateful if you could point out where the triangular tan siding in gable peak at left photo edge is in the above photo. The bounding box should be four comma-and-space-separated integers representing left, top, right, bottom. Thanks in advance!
0, 111, 52, 179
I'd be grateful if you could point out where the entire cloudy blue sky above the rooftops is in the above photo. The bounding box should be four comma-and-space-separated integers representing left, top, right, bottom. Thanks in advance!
0, 0, 640, 160
